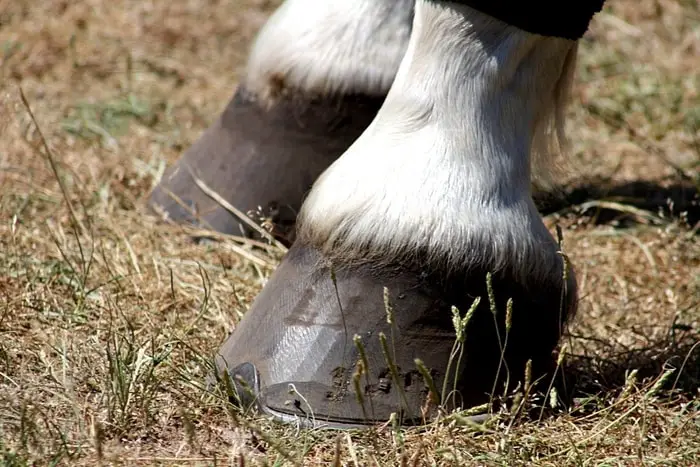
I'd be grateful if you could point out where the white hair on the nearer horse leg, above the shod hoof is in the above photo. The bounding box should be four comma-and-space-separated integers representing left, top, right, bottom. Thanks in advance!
298, 0, 577, 279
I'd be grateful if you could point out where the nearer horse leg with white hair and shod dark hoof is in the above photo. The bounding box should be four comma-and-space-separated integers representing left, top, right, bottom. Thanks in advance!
217, 0, 601, 426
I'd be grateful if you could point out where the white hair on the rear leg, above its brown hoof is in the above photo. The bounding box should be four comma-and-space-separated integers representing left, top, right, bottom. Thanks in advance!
244, 0, 413, 98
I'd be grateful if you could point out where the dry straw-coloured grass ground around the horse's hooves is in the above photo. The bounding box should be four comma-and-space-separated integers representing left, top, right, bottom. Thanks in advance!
0, 0, 700, 466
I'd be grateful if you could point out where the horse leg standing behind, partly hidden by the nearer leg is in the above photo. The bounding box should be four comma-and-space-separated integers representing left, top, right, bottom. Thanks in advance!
150, 0, 413, 242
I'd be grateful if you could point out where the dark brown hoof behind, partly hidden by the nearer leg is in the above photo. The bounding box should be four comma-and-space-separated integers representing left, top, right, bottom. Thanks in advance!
149, 87, 384, 243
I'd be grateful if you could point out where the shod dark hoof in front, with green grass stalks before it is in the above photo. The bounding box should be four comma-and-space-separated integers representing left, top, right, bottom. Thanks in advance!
217, 243, 575, 427
